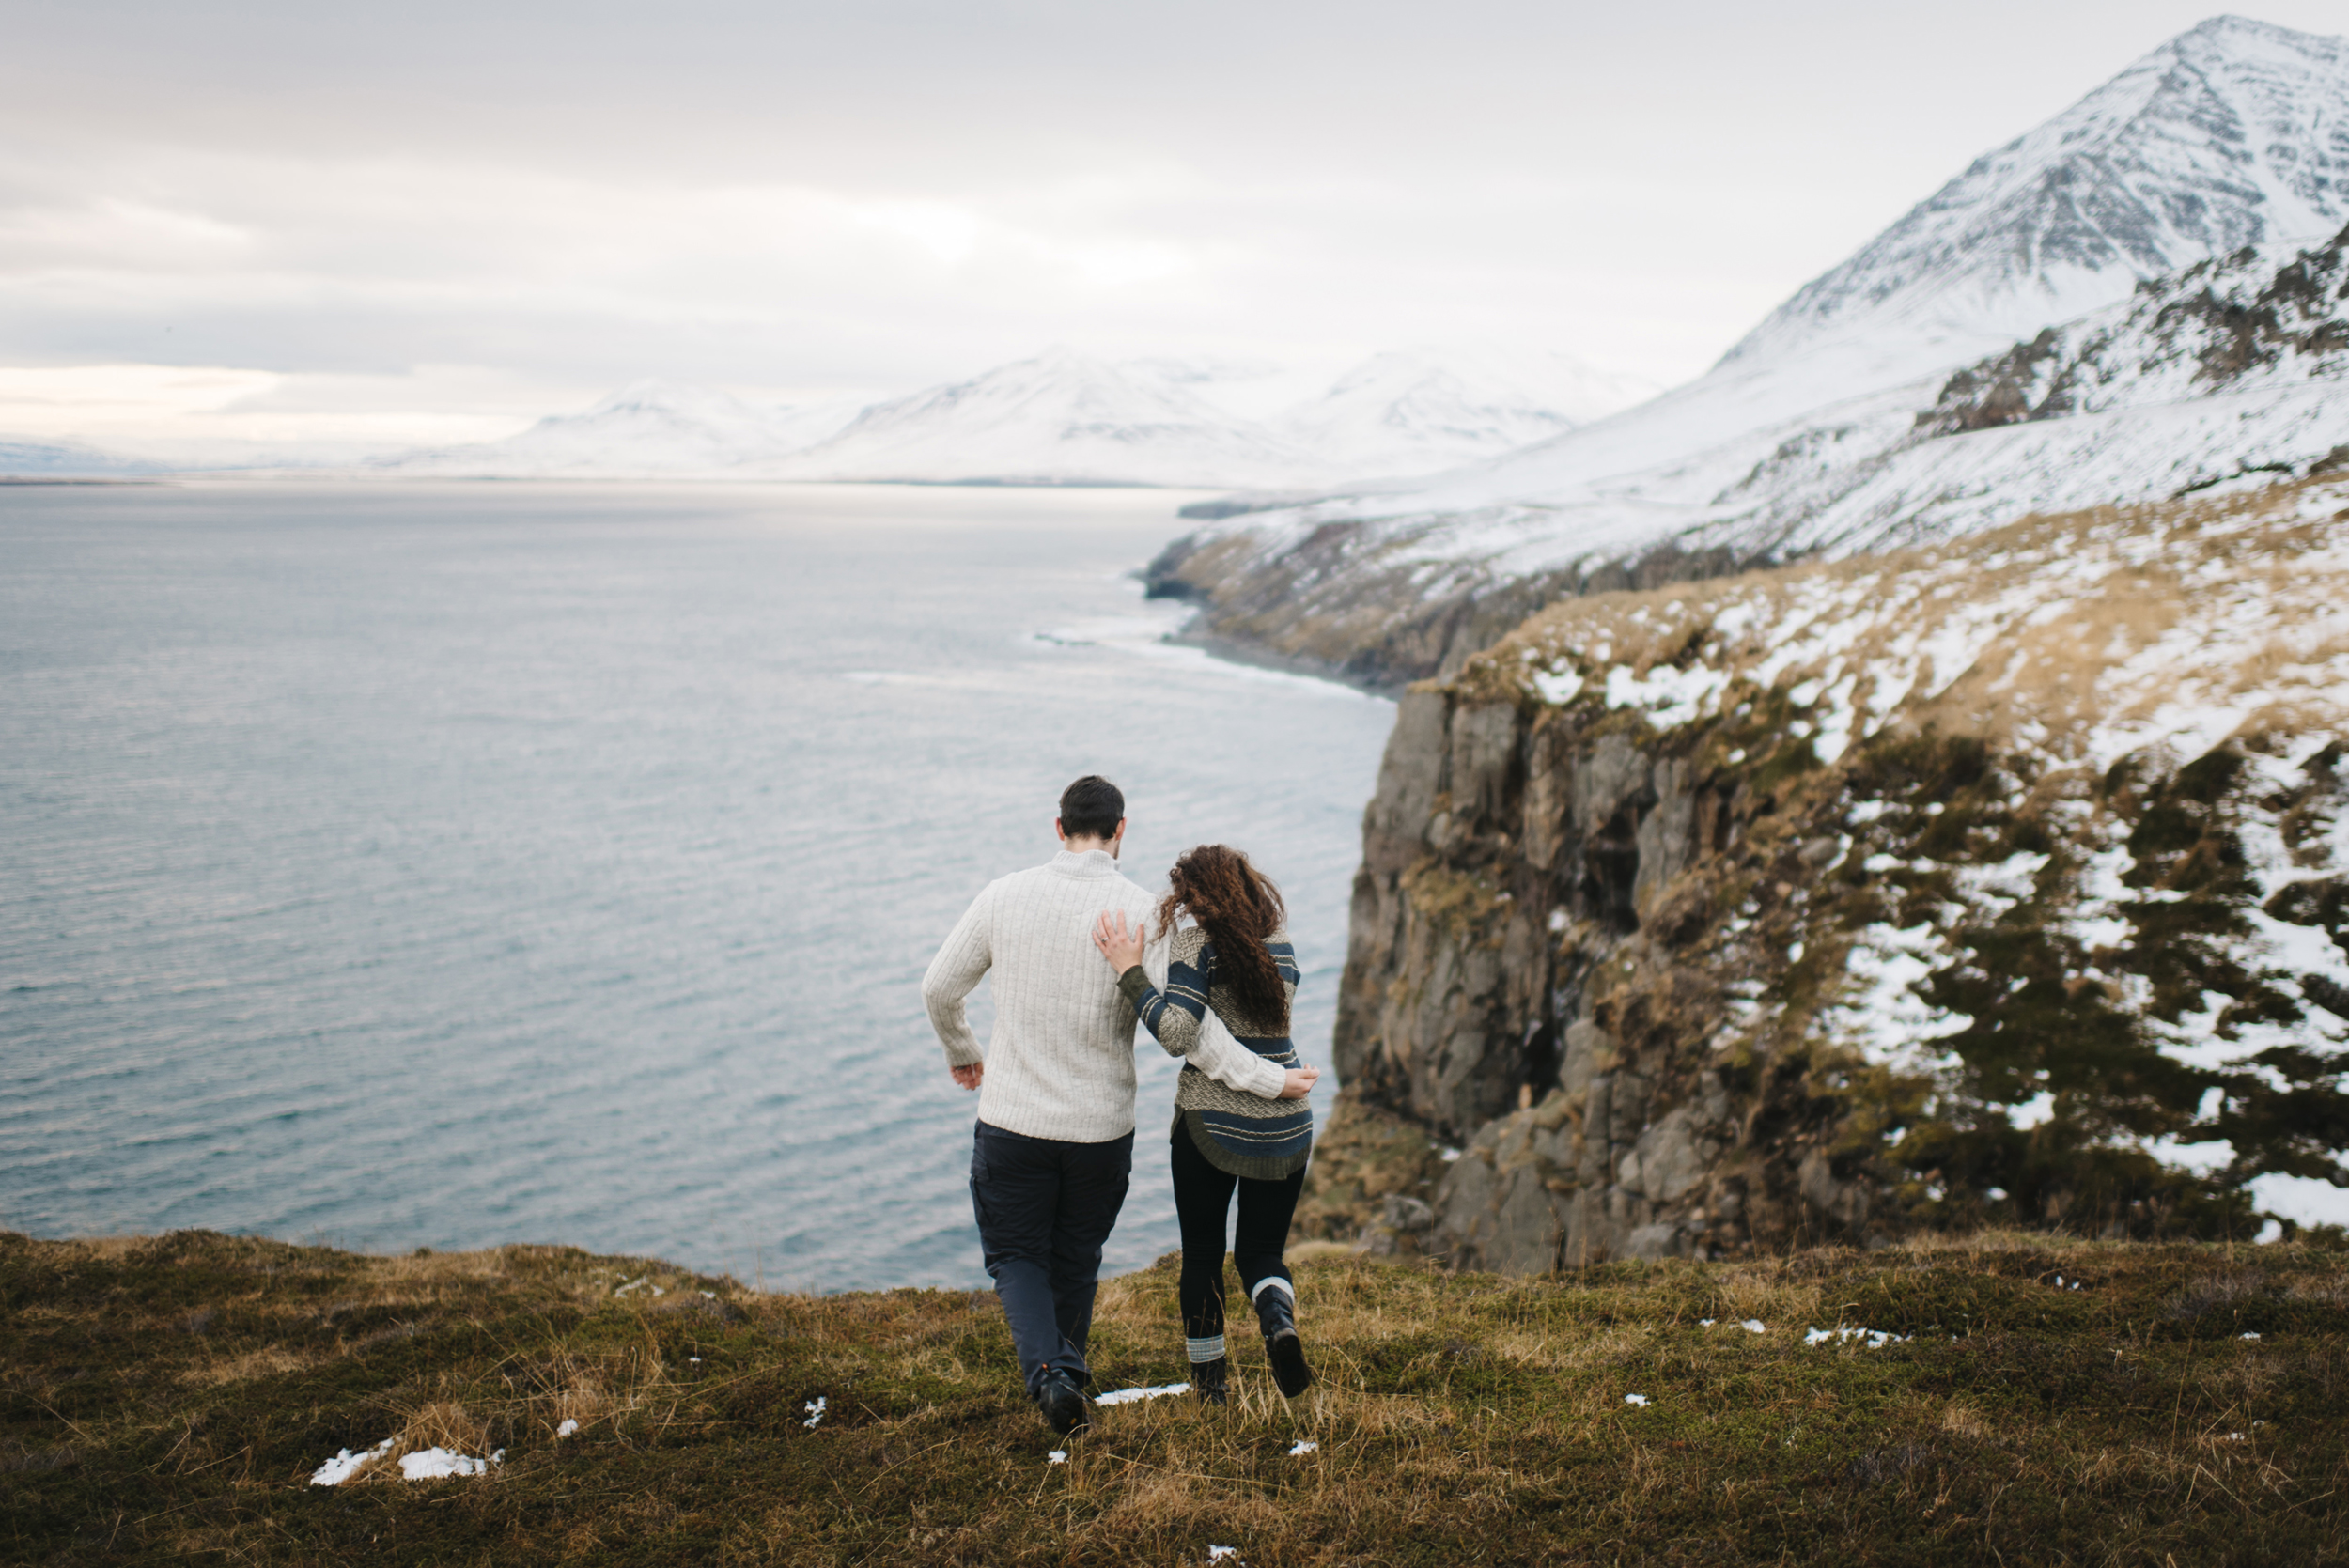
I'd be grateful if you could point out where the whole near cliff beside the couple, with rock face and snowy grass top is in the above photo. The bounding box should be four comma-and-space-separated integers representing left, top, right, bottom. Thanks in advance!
1306, 484, 2349, 1272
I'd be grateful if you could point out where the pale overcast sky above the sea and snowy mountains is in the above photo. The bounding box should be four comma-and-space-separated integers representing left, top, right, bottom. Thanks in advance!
0, 0, 2349, 460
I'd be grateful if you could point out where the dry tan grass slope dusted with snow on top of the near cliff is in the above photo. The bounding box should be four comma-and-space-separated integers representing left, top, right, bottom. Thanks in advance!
1461, 479, 2349, 769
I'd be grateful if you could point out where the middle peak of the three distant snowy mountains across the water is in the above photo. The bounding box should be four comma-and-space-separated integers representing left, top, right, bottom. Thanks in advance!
764, 348, 1325, 486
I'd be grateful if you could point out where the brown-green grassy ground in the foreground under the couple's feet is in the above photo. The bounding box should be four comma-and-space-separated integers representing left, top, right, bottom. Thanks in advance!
0, 1233, 2349, 1568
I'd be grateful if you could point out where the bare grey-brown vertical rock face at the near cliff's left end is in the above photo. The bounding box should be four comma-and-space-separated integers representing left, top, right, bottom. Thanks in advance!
1334, 688, 1743, 1272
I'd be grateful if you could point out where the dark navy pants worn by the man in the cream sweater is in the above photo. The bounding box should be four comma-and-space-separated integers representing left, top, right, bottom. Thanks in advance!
971, 1122, 1135, 1397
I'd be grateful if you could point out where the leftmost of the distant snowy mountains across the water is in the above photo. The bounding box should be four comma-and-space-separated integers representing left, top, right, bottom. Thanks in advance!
376, 380, 863, 479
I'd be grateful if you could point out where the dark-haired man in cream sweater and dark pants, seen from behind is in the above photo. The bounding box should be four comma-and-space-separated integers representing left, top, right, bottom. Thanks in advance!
921, 775, 1156, 1435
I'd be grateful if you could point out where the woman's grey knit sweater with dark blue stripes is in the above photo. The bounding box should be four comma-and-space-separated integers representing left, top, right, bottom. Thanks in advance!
1118, 924, 1314, 1181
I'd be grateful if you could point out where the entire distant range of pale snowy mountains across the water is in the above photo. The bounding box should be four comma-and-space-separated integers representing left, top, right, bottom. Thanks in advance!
374, 348, 1652, 490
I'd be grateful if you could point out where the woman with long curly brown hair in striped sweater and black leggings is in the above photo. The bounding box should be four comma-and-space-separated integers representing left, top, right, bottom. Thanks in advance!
1093, 845, 1320, 1404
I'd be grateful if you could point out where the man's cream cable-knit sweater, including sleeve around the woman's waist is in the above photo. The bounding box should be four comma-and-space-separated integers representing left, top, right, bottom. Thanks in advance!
921, 849, 1287, 1143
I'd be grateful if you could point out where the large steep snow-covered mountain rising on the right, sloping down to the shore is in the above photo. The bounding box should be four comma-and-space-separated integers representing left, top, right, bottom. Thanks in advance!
1154, 16, 2349, 678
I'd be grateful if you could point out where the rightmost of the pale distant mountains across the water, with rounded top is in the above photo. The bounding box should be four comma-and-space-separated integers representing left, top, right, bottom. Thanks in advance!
1273, 348, 1657, 474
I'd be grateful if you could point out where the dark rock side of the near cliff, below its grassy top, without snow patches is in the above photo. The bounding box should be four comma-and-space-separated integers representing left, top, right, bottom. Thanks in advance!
1299, 672, 2349, 1272
